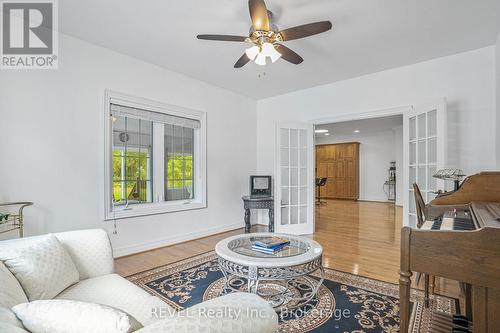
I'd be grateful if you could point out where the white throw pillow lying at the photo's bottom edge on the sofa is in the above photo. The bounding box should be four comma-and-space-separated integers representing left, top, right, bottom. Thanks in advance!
12, 300, 130, 333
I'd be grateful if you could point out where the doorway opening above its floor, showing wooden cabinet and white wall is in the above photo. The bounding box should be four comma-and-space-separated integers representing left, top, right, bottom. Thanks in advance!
315, 114, 403, 208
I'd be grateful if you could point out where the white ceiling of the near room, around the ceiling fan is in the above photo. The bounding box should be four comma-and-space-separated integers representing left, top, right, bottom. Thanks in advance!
59, 0, 500, 99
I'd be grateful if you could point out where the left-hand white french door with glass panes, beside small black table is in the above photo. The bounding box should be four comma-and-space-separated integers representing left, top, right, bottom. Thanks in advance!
274, 123, 314, 235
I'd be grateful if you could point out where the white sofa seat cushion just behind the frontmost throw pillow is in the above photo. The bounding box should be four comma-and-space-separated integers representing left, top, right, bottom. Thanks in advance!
56, 274, 170, 329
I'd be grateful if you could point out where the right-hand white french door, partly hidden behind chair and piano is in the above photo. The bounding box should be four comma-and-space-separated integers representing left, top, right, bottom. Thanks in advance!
403, 99, 447, 227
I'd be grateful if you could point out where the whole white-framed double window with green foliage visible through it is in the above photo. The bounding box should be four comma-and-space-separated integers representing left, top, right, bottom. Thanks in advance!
105, 92, 206, 219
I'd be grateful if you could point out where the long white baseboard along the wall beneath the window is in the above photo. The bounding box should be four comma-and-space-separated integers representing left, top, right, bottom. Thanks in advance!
113, 222, 244, 258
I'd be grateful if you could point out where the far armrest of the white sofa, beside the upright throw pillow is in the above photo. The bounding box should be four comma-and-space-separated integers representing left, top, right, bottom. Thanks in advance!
54, 229, 114, 280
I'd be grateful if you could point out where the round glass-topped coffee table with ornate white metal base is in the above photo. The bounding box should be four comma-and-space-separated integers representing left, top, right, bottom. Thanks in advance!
215, 233, 324, 311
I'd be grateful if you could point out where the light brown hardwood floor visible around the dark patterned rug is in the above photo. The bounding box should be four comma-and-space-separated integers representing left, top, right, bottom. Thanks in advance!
115, 200, 458, 297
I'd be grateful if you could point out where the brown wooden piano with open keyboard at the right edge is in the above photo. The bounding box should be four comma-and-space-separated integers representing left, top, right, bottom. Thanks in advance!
399, 172, 500, 332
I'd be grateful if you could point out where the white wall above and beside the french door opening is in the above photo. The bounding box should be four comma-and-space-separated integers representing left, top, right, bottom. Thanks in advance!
257, 46, 496, 202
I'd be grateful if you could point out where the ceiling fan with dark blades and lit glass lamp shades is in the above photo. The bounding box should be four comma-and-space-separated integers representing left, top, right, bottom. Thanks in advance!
197, 0, 332, 68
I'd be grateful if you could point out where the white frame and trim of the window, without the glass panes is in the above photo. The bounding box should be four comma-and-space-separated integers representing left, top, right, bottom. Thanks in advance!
104, 90, 207, 220
